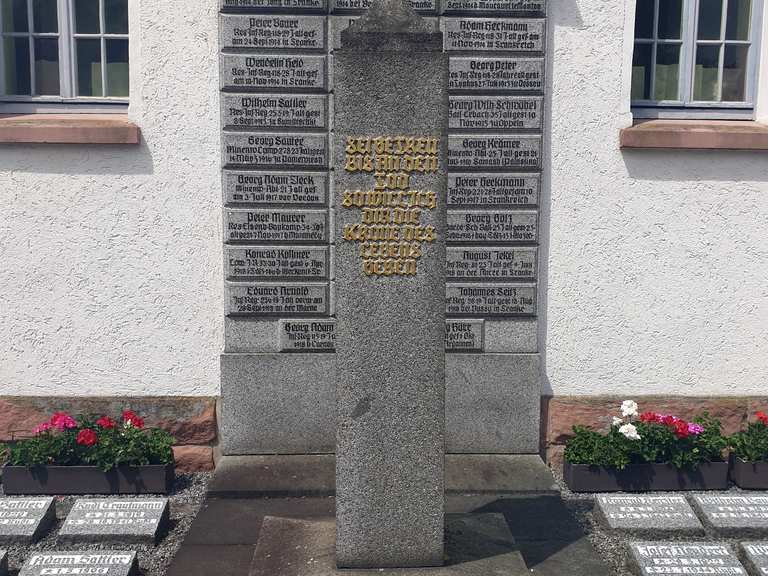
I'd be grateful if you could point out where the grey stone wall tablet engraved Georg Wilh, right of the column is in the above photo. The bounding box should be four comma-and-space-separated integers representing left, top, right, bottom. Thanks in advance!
448, 96, 544, 130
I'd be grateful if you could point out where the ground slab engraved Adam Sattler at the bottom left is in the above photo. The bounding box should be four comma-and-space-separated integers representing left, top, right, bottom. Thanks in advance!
19, 550, 139, 576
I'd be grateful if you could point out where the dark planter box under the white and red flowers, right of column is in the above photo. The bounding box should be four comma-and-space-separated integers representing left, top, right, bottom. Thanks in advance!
563, 462, 728, 492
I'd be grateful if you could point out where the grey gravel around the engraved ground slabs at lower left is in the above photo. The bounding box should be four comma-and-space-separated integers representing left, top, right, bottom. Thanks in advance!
0, 473, 212, 576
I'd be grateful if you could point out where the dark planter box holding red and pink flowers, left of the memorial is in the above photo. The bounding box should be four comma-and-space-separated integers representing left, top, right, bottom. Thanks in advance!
3, 464, 174, 495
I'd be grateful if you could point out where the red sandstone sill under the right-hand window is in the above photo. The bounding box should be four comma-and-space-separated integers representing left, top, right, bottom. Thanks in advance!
620, 120, 768, 150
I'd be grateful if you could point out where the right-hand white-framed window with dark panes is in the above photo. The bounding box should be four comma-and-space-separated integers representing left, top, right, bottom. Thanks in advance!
632, 0, 762, 119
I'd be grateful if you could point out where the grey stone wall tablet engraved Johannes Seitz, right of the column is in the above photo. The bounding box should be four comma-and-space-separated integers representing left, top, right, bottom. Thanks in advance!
445, 284, 536, 316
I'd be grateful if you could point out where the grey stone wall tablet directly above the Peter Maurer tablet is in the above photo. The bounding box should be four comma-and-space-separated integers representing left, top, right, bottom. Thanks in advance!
223, 170, 328, 206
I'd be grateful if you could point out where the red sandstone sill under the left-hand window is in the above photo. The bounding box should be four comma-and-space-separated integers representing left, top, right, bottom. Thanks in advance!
0, 114, 139, 144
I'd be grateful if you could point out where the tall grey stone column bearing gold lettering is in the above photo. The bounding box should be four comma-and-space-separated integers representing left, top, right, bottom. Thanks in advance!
333, 0, 448, 568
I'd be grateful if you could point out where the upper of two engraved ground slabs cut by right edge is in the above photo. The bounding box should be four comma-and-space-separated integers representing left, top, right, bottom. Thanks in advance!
693, 492, 768, 537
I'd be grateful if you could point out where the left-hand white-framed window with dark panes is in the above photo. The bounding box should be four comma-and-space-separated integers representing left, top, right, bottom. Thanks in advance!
0, 0, 129, 108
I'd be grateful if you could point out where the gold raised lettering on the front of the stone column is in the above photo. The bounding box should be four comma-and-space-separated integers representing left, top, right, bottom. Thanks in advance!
341, 136, 439, 276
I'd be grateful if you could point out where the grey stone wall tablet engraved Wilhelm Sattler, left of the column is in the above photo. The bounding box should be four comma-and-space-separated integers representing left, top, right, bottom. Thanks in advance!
221, 94, 328, 130
